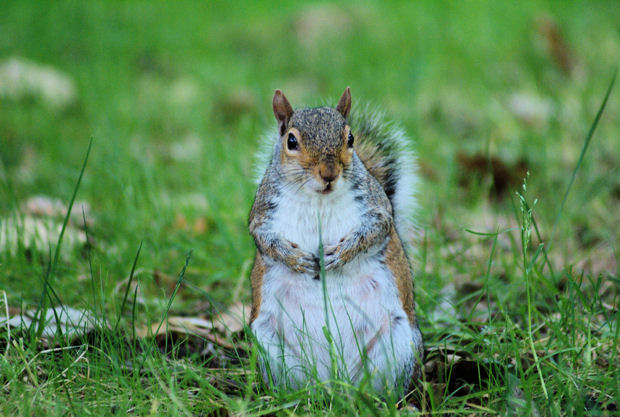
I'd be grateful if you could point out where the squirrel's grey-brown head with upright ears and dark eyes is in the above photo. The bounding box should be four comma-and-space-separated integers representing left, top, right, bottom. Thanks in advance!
273, 87, 355, 194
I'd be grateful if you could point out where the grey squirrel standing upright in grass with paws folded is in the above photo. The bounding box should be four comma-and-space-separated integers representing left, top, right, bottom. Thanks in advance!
249, 87, 423, 392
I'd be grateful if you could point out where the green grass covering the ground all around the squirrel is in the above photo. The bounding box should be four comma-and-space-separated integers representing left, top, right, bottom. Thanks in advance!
0, 0, 620, 415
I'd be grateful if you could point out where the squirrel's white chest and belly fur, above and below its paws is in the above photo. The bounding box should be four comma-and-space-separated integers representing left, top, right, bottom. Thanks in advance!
252, 185, 420, 390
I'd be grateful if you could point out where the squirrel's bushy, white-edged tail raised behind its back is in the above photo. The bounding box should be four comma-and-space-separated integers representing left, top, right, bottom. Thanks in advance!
349, 106, 418, 246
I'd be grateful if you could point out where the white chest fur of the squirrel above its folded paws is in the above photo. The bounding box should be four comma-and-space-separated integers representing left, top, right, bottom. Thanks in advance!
272, 188, 361, 253
